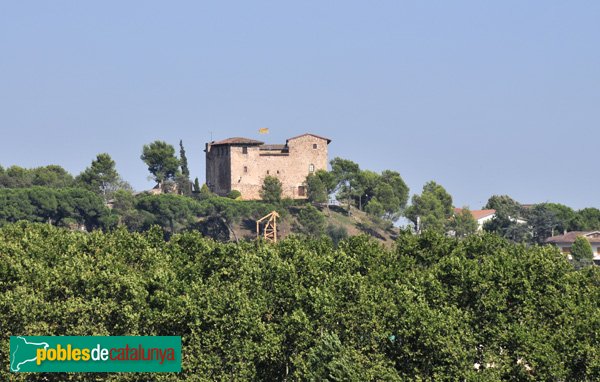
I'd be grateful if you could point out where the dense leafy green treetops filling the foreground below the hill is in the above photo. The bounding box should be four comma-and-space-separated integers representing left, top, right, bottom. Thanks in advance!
0, 225, 600, 381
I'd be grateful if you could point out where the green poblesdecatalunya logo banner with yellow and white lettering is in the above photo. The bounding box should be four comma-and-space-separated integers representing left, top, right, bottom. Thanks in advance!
10, 336, 181, 373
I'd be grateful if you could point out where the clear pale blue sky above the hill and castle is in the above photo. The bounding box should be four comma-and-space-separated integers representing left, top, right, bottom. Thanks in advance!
0, 0, 600, 209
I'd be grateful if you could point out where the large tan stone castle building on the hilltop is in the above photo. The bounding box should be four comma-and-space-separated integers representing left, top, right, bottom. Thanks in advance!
204, 134, 331, 200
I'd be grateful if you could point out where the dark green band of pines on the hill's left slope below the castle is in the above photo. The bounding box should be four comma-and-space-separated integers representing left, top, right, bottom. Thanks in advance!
0, 187, 287, 241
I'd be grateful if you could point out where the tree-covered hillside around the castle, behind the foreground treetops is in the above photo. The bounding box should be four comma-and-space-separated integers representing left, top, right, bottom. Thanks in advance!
5, 141, 600, 245
